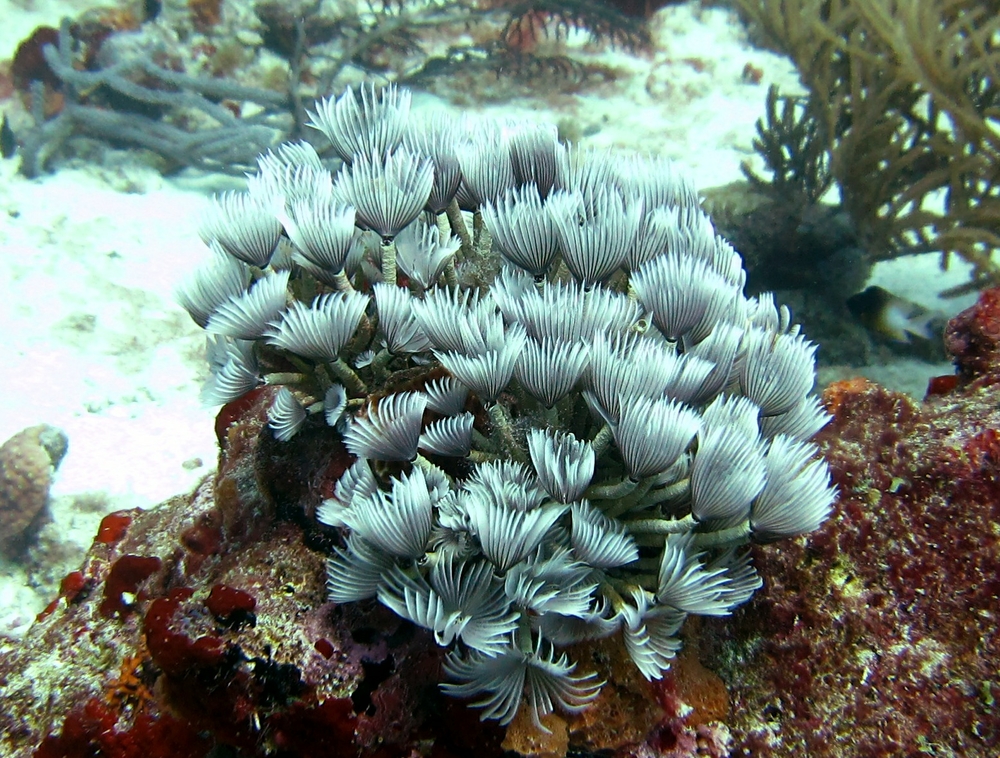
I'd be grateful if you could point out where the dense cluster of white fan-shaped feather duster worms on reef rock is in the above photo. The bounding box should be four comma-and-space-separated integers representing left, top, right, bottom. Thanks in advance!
179, 87, 834, 727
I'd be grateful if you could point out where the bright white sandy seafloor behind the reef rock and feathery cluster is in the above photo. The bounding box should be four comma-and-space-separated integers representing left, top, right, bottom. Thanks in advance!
0, 0, 969, 635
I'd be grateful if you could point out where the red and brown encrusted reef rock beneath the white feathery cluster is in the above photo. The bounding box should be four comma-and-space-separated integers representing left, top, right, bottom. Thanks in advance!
0, 290, 1000, 758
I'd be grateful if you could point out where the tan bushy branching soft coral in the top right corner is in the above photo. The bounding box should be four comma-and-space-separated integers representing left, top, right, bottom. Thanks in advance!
734, 0, 1000, 296
